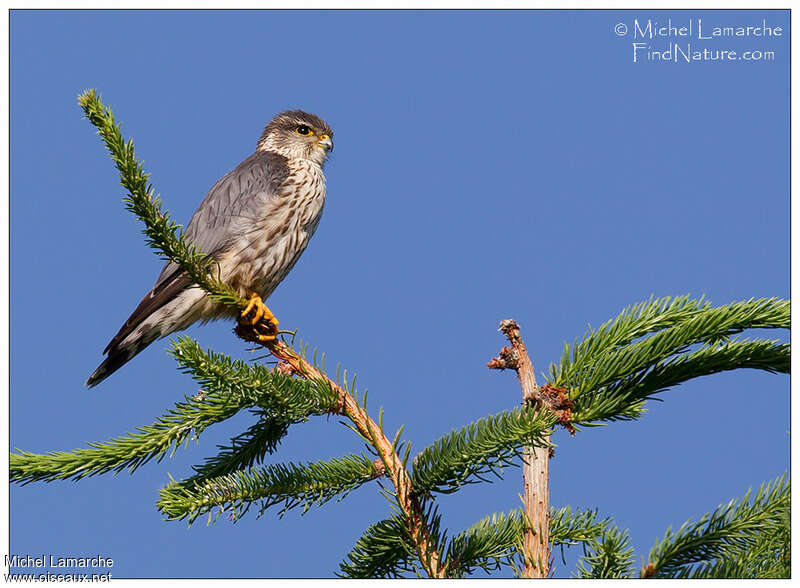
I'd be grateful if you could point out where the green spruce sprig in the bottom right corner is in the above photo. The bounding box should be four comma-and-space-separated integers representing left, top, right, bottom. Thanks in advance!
642, 475, 791, 578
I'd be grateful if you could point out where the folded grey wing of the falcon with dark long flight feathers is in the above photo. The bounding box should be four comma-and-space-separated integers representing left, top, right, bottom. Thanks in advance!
103, 152, 289, 353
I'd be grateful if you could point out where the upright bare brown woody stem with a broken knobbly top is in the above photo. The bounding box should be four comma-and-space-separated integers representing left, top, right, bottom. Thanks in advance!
488, 319, 552, 578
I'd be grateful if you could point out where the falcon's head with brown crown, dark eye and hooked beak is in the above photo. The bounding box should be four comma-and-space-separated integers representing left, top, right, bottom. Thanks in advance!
258, 110, 333, 165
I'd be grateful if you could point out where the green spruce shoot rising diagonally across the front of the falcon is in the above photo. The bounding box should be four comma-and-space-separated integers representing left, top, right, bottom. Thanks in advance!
78, 89, 247, 308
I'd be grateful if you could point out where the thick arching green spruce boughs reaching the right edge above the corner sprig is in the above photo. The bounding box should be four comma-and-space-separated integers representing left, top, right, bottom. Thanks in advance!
550, 296, 790, 425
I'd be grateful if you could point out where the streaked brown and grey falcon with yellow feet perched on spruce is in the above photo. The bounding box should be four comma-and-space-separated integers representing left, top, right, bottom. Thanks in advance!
86, 110, 333, 388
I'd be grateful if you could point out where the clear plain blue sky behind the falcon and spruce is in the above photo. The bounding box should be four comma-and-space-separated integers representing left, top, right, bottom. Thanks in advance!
10, 10, 789, 577
